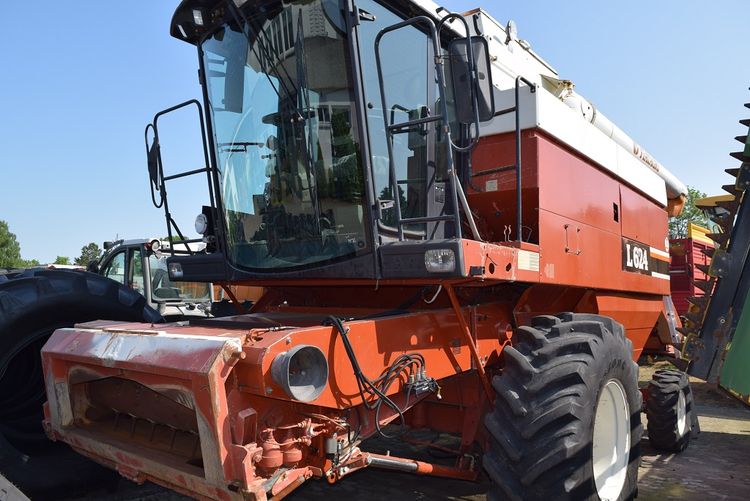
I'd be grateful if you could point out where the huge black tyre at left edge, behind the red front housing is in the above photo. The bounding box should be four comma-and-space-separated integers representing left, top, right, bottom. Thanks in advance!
0, 270, 163, 498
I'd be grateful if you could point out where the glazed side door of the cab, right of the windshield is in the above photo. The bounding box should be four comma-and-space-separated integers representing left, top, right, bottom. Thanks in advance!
357, 0, 453, 243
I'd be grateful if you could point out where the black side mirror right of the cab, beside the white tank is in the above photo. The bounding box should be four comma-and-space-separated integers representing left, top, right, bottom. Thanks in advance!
448, 36, 495, 124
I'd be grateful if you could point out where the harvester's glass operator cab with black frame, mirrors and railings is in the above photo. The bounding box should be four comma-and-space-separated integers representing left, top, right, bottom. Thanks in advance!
146, 0, 494, 281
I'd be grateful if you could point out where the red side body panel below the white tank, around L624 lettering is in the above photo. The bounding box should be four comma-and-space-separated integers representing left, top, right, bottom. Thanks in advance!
468, 131, 669, 296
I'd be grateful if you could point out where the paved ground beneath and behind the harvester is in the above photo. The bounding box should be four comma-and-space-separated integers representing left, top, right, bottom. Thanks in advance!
55, 363, 750, 501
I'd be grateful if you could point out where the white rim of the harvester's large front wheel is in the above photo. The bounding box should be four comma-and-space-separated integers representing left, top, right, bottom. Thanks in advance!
592, 379, 630, 500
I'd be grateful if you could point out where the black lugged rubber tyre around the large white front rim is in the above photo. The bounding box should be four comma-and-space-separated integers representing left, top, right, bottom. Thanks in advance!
485, 313, 641, 500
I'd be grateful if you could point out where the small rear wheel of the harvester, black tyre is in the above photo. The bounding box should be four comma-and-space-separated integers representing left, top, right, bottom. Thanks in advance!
646, 369, 694, 453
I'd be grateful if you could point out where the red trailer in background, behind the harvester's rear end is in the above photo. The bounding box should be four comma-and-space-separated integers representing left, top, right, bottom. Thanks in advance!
669, 223, 715, 317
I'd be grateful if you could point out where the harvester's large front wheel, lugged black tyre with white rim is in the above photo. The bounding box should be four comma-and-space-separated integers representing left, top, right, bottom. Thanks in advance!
484, 313, 642, 501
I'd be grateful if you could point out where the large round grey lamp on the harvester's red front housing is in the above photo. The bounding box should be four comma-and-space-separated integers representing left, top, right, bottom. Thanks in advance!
271, 344, 328, 402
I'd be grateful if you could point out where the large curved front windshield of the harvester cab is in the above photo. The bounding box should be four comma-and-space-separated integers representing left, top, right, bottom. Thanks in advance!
201, 0, 368, 269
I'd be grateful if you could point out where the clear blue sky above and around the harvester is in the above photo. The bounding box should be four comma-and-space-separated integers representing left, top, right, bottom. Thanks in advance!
0, 0, 750, 262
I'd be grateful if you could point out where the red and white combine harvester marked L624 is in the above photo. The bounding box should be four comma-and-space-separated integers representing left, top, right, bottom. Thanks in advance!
35, 0, 691, 500
